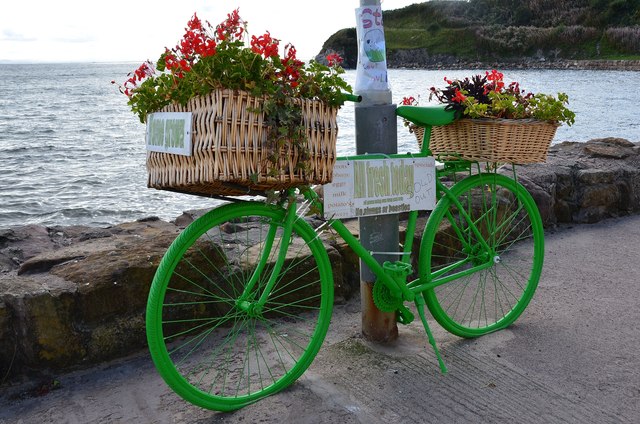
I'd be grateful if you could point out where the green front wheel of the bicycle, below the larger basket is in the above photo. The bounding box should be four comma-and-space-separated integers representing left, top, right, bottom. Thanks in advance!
146, 202, 333, 411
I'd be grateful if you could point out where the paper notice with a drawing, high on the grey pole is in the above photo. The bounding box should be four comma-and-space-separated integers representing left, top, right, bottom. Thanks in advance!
355, 5, 389, 93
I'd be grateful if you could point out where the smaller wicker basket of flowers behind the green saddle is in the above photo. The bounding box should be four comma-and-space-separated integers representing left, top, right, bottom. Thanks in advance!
402, 70, 575, 163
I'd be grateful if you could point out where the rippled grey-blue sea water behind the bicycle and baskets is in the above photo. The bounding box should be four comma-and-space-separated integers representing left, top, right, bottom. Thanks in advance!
0, 63, 640, 229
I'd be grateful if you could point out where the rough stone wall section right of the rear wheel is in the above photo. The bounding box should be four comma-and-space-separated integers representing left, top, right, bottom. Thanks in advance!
518, 138, 640, 227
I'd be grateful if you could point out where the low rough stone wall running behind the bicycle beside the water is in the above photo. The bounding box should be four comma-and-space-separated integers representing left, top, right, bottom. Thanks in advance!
0, 138, 640, 386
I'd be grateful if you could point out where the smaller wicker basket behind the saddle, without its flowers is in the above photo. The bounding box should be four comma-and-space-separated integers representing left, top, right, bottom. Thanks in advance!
410, 119, 559, 164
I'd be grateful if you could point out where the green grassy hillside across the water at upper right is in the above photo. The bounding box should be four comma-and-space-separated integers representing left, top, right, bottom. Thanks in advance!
323, 0, 640, 67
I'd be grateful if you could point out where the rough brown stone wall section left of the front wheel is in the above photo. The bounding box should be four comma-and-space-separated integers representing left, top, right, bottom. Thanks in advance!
0, 220, 179, 375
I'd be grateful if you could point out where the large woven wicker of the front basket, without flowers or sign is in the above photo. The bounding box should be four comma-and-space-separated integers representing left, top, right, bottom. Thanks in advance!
147, 89, 338, 196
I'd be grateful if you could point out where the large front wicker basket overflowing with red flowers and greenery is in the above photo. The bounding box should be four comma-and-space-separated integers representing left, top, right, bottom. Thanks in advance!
120, 9, 352, 195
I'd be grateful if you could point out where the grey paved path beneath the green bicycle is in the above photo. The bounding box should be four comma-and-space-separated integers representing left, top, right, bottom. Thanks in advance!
0, 216, 640, 424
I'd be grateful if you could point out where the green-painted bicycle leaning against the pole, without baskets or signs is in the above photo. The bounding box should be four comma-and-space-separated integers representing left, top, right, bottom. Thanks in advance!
146, 102, 544, 411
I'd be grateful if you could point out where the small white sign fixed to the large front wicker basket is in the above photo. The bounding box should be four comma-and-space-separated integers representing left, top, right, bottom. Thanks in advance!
146, 112, 192, 156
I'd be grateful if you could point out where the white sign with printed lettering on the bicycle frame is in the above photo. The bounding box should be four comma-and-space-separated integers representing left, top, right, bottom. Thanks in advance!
323, 157, 436, 218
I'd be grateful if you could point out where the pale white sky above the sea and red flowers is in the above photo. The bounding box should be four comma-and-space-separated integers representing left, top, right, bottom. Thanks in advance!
0, 0, 421, 63
